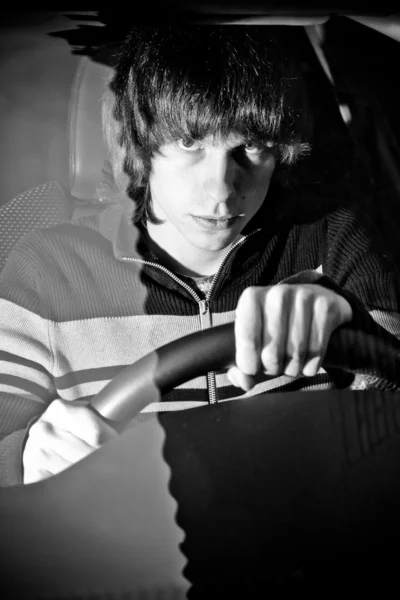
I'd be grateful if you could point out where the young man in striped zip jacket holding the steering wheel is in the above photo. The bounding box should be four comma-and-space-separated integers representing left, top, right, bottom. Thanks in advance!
0, 26, 400, 485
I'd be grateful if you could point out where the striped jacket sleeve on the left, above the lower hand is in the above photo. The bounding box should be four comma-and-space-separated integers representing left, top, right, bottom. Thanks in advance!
0, 244, 56, 486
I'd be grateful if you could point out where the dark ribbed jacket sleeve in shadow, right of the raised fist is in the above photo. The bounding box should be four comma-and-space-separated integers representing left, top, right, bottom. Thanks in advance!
319, 209, 400, 390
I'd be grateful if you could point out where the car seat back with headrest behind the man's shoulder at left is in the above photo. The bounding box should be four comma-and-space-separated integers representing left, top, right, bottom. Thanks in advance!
0, 44, 119, 271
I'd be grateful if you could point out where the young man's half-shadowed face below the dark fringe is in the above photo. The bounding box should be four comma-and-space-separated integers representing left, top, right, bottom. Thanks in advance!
148, 134, 275, 270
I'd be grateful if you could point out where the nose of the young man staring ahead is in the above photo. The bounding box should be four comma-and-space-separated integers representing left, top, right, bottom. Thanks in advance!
203, 152, 238, 210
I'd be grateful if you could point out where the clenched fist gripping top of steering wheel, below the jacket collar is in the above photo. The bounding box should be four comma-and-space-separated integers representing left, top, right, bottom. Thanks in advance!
228, 284, 353, 390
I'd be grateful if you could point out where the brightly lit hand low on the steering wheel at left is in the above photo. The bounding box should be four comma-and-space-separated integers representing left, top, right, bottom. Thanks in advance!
22, 400, 118, 483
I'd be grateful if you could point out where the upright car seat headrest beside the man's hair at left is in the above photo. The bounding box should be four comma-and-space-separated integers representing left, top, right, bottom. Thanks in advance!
69, 44, 120, 201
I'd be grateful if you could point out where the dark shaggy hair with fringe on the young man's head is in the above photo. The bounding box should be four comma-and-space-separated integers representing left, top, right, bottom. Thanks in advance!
103, 25, 312, 222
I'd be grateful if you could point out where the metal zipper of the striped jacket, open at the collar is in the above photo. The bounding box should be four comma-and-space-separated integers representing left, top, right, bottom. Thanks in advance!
121, 229, 260, 404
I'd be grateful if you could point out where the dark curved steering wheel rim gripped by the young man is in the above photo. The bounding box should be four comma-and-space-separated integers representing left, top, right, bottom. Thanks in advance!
91, 319, 400, 429
